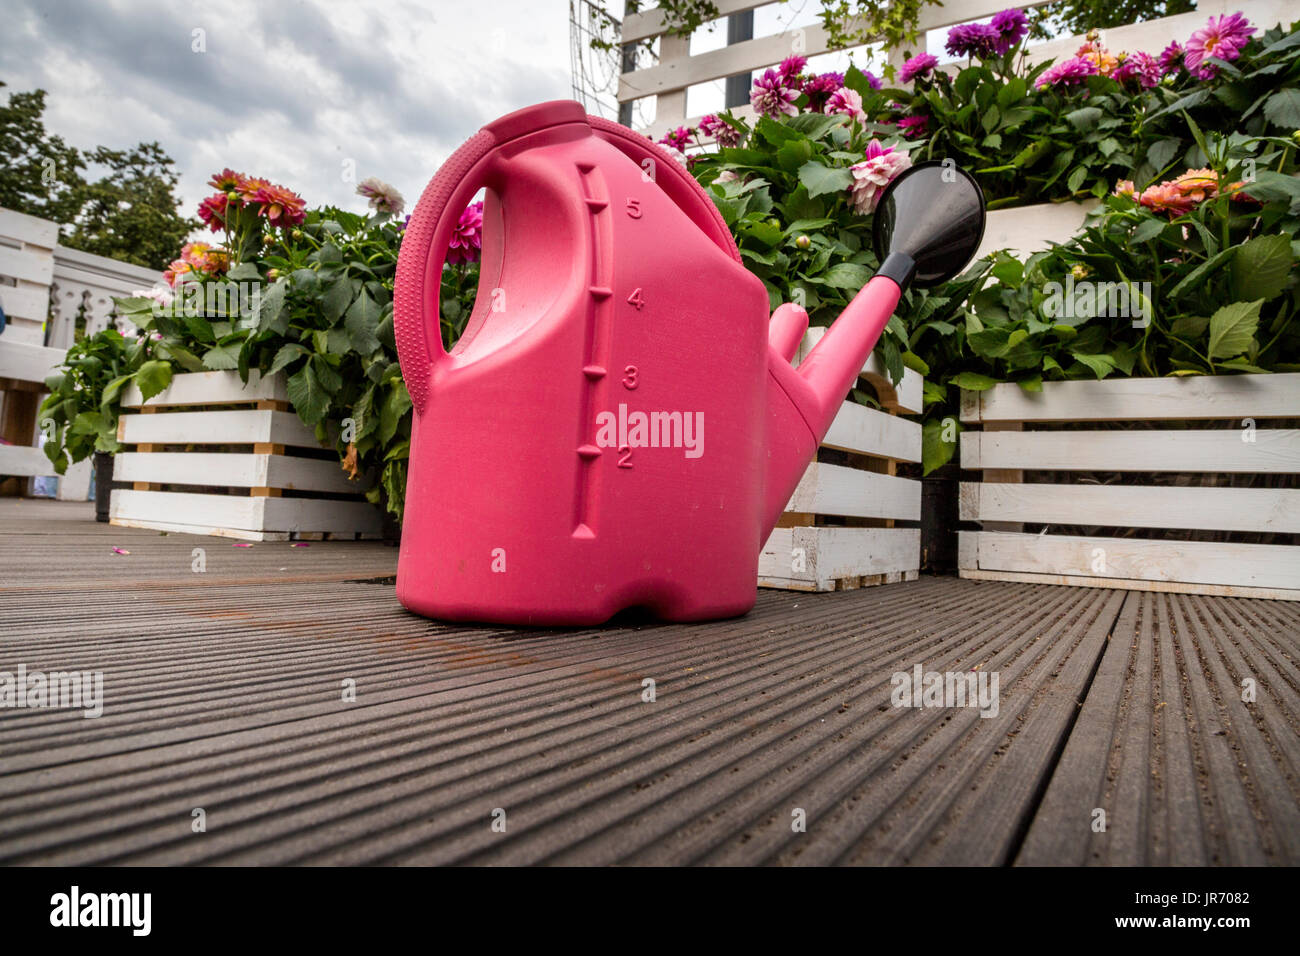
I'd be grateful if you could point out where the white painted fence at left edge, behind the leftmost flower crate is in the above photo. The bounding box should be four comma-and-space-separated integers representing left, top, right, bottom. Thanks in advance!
0, 209, 163, 501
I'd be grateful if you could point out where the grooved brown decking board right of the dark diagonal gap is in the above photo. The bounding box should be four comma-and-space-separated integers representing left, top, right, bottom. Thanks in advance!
1017, 594, 1300, 866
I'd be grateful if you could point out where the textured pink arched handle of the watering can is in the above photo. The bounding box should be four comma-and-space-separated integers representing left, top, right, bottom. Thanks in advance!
393, 100, 741, 412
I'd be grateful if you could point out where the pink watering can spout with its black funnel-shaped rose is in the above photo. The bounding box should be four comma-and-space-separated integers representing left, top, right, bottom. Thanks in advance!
764, 163, 984, 528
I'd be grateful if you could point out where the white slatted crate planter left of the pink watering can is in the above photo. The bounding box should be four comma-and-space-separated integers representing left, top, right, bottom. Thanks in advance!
109, 372, 382, 541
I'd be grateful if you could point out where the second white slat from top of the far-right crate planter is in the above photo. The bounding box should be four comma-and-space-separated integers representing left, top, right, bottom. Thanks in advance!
961, 429, 1300, 473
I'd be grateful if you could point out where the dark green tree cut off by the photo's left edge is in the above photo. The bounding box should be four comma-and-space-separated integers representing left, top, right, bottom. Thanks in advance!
0, 81, 86, 222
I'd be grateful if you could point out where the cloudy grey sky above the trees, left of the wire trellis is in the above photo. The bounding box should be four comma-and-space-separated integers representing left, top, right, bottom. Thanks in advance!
0, 0, 569, 221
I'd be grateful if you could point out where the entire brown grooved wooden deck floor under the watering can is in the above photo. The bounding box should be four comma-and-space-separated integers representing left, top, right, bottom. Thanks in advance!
0, 499, 1300, 865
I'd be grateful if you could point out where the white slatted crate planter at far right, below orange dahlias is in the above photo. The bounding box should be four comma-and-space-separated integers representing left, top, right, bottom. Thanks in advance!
958, 375, 1300, 600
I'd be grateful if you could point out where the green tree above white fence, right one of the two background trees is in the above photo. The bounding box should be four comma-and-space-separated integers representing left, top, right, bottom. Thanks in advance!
61, 143, 199, 269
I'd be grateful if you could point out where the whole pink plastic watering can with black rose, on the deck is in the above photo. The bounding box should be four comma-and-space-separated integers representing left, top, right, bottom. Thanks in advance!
394, 100, 984, 624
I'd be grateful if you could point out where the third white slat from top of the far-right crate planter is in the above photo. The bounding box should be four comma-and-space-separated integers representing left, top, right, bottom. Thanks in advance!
961, 481, 1300, 535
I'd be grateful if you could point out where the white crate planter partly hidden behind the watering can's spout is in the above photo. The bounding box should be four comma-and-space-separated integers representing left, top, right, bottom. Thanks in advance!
758, 329, 922, 591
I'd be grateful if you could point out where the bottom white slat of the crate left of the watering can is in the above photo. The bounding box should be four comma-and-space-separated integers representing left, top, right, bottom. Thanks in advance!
109, 489, 382, 541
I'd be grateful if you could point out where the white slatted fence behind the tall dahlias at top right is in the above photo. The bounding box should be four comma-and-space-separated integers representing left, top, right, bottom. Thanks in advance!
618, 0, 1300, 139
